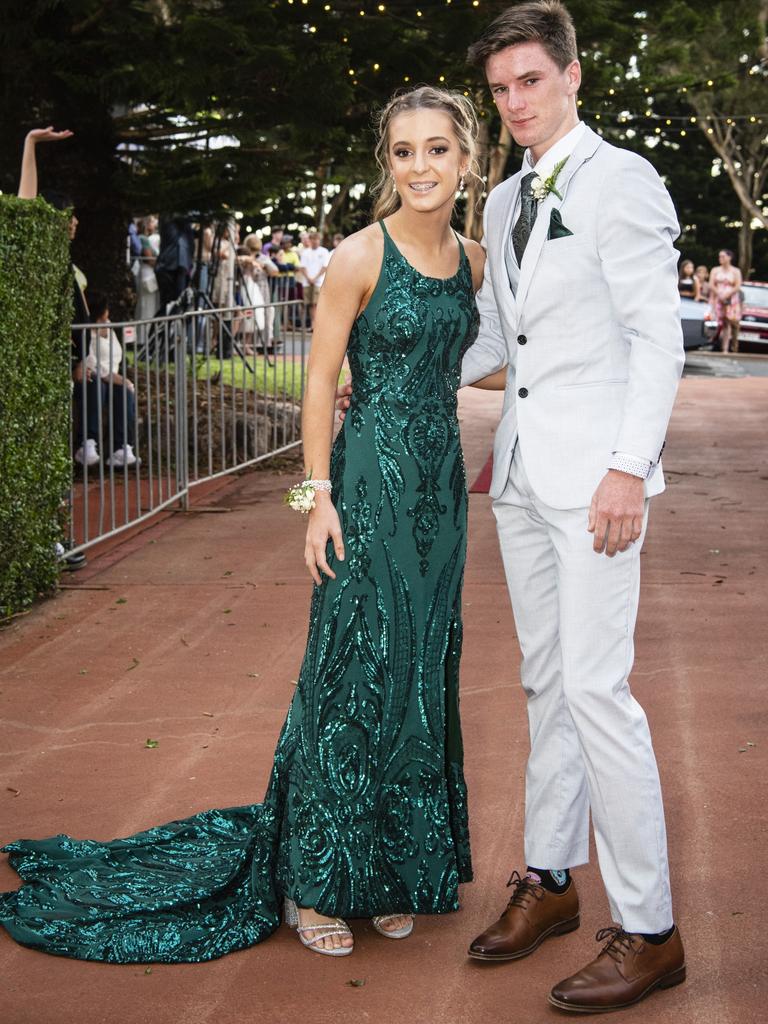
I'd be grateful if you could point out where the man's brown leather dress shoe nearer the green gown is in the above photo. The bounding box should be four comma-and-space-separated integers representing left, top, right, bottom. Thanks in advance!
469, 871, 579, 961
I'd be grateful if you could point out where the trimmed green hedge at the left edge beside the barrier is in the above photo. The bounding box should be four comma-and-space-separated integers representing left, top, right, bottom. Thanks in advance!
0, 195, 72, 620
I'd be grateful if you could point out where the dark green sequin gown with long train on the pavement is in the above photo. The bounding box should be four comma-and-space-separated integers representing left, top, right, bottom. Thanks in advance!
0, 224, 477, 963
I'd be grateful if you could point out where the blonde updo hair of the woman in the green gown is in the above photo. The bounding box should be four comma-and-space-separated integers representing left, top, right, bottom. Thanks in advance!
371, 85, 479, 220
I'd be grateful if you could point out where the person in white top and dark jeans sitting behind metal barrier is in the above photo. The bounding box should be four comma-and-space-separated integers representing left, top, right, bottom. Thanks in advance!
75, 293, 138, 467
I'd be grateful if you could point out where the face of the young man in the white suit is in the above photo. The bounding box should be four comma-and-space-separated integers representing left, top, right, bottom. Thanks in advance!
485, 43, 582, 156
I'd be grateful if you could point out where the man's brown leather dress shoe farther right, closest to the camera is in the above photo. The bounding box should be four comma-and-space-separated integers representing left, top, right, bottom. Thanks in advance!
549, 928, 685, 1014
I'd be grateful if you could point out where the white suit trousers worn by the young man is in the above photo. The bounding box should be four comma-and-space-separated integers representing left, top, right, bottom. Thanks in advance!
494, 444, 673, 933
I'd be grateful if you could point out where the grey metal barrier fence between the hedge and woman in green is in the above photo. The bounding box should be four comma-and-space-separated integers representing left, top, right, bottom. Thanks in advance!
66, 288, 307, 554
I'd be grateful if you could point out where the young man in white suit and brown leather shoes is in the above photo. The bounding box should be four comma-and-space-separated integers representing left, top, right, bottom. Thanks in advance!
462, 0, 685, 1013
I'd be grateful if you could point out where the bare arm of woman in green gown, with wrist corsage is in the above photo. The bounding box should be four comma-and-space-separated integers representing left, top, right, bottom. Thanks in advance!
301, 232, 381, 584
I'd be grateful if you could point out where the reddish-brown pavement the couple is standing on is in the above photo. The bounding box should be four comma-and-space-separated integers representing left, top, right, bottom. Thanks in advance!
0, 378, 768, 1024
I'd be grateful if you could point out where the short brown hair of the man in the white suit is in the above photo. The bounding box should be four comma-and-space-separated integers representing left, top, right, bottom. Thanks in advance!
467, 0, 579, 71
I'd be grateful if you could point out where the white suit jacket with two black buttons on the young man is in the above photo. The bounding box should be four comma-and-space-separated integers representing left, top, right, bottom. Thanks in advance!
462, 128, 684, 509
